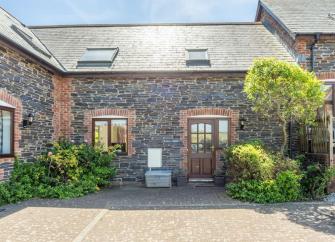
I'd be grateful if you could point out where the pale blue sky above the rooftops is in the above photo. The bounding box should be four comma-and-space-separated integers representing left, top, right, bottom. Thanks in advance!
0, 0, 258, 25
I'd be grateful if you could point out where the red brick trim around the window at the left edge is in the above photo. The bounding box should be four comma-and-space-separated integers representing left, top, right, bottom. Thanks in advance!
0, 89, 22, 163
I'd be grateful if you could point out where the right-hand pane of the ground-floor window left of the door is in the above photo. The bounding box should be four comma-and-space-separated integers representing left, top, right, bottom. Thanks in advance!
111, 119, 127, 152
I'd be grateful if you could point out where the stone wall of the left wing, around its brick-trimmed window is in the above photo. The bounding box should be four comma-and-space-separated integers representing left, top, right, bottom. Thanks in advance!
0, 42, 54, 180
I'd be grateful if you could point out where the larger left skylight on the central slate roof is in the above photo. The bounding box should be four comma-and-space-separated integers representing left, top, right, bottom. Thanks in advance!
77, 48, 119, 68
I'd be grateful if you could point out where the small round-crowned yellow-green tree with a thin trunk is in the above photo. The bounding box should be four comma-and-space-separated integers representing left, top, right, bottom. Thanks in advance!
244, 58, 325, 155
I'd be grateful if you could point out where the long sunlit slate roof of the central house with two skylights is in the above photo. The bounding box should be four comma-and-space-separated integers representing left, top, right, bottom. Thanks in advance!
31, 23, 294, 72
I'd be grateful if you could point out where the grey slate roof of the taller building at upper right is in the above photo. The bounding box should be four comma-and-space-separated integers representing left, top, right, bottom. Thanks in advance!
260, 0, 335, 34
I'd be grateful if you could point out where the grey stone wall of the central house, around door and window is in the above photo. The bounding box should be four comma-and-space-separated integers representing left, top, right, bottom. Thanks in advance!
71, 75, 281, 180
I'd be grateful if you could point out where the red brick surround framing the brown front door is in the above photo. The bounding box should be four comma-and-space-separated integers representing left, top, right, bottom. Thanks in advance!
179, 108, 239, 169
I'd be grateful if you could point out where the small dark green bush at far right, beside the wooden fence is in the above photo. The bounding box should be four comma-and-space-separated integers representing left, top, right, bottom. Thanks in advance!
301, 164, 335, 199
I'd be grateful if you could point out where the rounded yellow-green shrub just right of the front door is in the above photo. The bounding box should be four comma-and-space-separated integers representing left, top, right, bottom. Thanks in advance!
226, 141, 274, 182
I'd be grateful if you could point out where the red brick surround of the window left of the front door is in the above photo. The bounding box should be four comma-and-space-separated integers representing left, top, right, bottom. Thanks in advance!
84, 108, 136, 156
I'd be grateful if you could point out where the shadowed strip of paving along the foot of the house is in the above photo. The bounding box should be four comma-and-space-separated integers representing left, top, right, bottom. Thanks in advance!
0, 185, 335, 235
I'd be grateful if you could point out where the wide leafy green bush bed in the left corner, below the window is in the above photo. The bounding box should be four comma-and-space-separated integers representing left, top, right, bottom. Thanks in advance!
0, 141, 116, 204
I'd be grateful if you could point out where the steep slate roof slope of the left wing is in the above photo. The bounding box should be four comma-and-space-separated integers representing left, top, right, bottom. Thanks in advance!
0, 7, 62, 69
